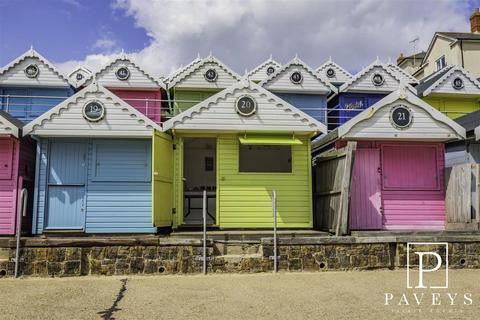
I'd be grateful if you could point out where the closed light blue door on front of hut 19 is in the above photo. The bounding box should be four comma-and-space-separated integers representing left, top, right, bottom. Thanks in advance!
46, 141, 87, 230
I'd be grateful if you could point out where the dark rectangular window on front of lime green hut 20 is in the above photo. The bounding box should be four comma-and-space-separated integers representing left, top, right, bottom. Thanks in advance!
239, 144, 292, 172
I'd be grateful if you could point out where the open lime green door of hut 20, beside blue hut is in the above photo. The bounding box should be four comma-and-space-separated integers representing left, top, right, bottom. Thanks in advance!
152, 131, 173, 227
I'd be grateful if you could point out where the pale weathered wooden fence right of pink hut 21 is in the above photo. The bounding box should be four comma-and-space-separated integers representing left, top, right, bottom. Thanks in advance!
445, 163, 480, 231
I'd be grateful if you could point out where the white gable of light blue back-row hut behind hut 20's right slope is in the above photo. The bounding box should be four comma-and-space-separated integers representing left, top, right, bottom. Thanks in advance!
259, 56, 337, 94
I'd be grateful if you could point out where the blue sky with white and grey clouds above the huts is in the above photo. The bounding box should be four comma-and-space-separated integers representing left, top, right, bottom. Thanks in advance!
0, 0, 480, 75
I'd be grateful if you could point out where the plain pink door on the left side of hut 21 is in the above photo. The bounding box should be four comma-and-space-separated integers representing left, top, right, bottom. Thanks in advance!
350, 149, 382, 230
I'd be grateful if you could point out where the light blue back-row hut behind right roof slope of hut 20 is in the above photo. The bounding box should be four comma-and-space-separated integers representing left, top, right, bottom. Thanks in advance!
259, 56, 337, 124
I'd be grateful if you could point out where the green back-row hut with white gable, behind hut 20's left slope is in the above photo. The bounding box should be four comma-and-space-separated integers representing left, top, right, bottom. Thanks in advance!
166, 53, 240, 114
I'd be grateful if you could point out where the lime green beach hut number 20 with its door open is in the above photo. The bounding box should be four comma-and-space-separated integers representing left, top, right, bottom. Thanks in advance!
153, 79, 326, 229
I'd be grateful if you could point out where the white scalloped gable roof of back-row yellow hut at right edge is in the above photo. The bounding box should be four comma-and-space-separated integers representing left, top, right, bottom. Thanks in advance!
416, 65, 480, 97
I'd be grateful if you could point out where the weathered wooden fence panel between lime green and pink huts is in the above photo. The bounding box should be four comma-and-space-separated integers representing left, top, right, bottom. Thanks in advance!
313, 142, 357, 236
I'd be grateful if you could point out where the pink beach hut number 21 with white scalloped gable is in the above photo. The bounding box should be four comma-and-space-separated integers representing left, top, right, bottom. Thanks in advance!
312, 87, 465, 230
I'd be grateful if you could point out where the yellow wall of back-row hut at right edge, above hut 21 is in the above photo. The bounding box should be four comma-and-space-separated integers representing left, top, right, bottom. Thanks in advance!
423, 97, 480, 119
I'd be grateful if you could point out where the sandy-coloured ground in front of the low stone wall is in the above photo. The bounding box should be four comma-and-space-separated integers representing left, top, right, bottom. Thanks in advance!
0, 270, 480, 320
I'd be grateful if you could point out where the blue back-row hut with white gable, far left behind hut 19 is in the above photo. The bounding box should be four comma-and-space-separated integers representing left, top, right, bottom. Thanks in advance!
0, 48, 73, 122
